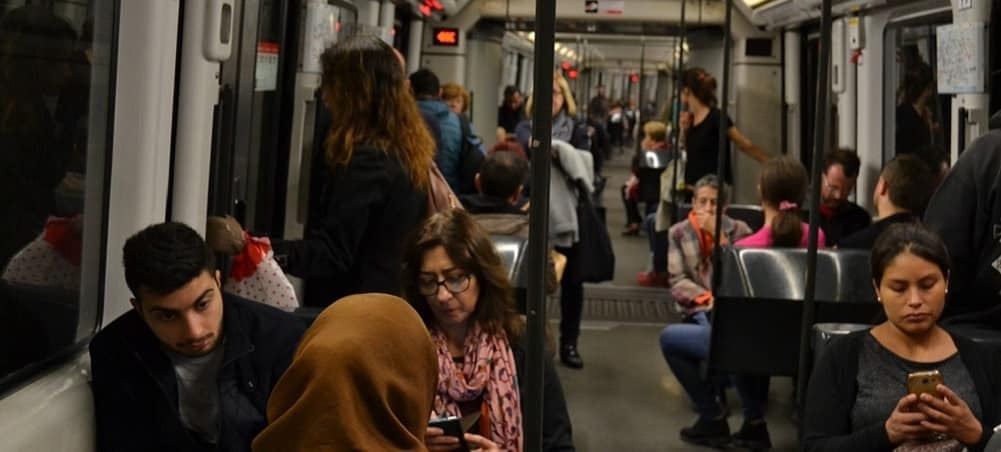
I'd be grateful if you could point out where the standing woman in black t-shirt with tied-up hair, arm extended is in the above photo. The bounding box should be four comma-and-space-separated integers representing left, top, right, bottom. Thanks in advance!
681, 67, 768, 190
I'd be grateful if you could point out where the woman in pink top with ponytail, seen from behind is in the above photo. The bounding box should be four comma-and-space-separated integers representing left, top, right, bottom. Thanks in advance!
734, 157, 824, 248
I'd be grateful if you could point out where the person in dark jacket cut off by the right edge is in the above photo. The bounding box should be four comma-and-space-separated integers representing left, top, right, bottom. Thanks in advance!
924, 130, 1001, 332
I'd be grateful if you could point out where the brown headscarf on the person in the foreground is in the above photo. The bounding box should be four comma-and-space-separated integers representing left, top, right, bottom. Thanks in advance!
253, 294, 437, 452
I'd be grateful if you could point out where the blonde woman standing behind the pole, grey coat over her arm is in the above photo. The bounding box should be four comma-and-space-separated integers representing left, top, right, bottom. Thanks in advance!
518, 73, 594, 369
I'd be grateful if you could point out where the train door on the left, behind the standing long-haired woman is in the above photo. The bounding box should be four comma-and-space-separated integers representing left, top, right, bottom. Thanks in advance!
208, 0, 357, 304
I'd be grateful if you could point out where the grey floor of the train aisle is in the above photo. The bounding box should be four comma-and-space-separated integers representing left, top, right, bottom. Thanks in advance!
549, 147, 797, 452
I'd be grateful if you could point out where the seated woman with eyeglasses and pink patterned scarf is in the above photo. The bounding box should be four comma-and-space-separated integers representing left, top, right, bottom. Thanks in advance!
403, 210, 575, 452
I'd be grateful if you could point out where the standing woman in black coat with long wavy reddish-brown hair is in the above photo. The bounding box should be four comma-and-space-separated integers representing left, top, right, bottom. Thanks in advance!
208, 35, 434, 306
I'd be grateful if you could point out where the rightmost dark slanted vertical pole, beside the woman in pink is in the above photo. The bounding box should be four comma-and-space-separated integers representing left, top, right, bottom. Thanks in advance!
796, 0, 831, 412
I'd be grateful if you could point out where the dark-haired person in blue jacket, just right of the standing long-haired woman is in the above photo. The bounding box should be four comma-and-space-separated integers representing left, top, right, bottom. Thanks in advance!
410, 69, 462, 193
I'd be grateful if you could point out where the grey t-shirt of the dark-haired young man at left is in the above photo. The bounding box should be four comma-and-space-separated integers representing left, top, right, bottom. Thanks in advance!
167, 342, 225, 444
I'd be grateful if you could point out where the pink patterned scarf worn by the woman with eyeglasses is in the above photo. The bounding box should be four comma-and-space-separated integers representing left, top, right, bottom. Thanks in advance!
431, 324, 523, 452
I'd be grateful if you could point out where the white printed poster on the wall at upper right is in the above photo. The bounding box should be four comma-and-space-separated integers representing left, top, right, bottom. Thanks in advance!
935, 23, 987, 94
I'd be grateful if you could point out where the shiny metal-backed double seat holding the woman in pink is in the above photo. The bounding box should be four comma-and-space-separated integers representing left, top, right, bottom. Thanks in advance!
709, 247, 881, 376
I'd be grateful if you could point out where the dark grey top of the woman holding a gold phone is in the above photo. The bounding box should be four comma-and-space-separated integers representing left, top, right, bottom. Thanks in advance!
852, 334, 981, 431
